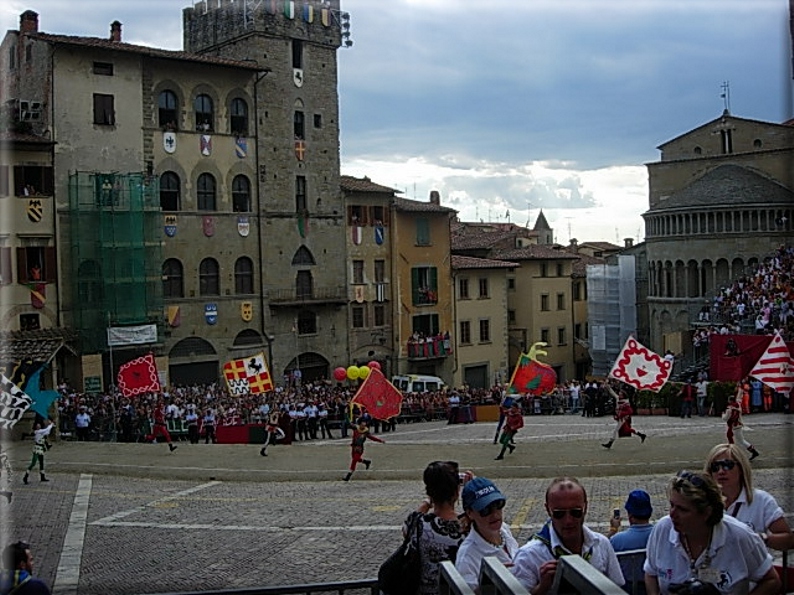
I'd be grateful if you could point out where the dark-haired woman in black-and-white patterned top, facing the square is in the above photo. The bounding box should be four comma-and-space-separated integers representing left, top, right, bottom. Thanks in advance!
403, 461, 472, 595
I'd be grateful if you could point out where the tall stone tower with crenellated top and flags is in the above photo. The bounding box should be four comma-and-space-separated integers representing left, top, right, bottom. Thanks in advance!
183, 0, 352, 379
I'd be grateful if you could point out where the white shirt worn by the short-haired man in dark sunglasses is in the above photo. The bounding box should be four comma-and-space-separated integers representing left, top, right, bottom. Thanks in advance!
510, 526, 626, 591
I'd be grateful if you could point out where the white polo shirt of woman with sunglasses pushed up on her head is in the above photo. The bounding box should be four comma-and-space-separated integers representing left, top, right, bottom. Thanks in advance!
643, 515, 772, 595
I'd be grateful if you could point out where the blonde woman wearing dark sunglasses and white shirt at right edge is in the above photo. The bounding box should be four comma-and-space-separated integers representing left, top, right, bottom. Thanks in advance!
703, 444, 794, 551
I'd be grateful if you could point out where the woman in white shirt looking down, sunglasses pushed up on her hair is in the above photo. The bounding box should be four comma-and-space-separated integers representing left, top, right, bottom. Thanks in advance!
643, 471, 780, 595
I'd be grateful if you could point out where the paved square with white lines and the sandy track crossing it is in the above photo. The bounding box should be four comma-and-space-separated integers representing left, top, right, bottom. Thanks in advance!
0, 414, 794, 595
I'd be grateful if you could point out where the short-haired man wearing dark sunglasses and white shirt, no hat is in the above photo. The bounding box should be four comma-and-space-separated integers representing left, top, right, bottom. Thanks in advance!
511, 477, 625, 595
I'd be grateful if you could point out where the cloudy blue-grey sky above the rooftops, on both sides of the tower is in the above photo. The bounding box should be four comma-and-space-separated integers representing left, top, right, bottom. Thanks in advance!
0, 0, 792, 244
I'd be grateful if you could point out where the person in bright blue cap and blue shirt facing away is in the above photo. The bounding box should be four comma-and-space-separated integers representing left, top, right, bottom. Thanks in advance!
609, 490, 653, 595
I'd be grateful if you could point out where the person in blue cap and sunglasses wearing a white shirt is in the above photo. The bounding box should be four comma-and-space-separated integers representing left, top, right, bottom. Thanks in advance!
455, 477, 518, 592
